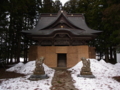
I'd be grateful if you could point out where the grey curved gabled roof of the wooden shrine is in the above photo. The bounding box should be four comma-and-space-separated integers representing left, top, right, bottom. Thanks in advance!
22, 10, 101, 35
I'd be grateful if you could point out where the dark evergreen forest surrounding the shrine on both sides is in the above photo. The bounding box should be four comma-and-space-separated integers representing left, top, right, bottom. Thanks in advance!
0, 0, 120, 64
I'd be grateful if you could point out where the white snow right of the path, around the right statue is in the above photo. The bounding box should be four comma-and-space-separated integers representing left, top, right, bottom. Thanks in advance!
68, 59, 120, 90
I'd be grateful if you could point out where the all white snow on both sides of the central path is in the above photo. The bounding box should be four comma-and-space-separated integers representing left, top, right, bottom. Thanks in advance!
0, 59, 120, 90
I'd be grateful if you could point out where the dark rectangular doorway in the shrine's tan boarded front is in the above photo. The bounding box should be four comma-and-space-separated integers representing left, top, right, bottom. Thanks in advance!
57, 54, 66, 67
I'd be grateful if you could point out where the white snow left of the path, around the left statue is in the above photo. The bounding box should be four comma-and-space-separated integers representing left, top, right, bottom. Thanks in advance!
0, 61, 55, 90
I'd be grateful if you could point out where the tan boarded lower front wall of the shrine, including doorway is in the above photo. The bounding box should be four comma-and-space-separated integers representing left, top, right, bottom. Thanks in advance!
29, 45, 95, 67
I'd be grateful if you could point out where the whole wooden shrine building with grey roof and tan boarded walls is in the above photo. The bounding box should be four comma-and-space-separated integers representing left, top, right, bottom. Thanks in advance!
22, 10, 100, 67
